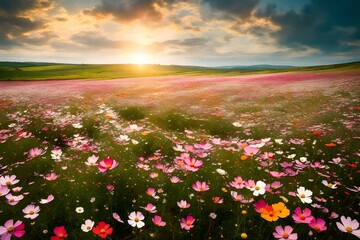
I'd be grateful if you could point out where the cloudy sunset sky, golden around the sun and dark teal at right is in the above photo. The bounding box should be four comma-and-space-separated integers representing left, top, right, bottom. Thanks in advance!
0, 0, 360, 66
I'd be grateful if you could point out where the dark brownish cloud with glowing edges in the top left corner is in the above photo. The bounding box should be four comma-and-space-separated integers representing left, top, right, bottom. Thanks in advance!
0, 0, 52, 49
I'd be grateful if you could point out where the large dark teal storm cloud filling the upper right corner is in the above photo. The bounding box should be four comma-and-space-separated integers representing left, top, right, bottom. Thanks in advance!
258, 0, 360, 53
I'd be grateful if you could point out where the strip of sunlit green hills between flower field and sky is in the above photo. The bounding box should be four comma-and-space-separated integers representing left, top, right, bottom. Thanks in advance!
0, 62, 360, 80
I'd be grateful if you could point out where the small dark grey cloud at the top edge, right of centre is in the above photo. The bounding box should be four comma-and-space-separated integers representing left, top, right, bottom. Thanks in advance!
202, 0, 259, 19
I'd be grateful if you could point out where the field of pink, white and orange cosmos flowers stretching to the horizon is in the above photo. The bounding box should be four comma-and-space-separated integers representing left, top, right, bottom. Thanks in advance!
0, 66, 360, 240
